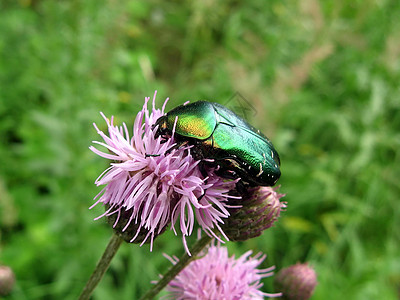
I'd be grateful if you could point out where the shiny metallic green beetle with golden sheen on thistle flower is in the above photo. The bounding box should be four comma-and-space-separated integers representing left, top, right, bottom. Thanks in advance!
154, 101, 281, 186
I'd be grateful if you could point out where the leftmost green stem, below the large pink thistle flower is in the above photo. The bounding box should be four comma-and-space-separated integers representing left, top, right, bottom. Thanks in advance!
79, 234, 123, 300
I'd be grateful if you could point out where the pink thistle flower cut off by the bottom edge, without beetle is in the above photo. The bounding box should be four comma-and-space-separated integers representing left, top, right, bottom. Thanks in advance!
167, 245, 282, 300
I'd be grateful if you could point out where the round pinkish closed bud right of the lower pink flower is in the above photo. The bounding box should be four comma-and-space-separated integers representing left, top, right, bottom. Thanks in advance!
275, 263, 317, 300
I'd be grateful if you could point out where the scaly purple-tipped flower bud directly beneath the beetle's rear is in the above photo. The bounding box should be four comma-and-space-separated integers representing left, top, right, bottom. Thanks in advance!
221, 186, 286, 241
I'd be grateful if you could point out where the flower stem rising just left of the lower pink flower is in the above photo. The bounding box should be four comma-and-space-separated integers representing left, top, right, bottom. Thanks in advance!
140, 235, 212, 300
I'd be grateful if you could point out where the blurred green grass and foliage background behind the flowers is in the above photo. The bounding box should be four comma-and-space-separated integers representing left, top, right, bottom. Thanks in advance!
0, 0, 400, 300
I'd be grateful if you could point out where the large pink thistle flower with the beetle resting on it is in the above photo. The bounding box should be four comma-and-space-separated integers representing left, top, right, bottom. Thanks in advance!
90, 92, 239, 253
